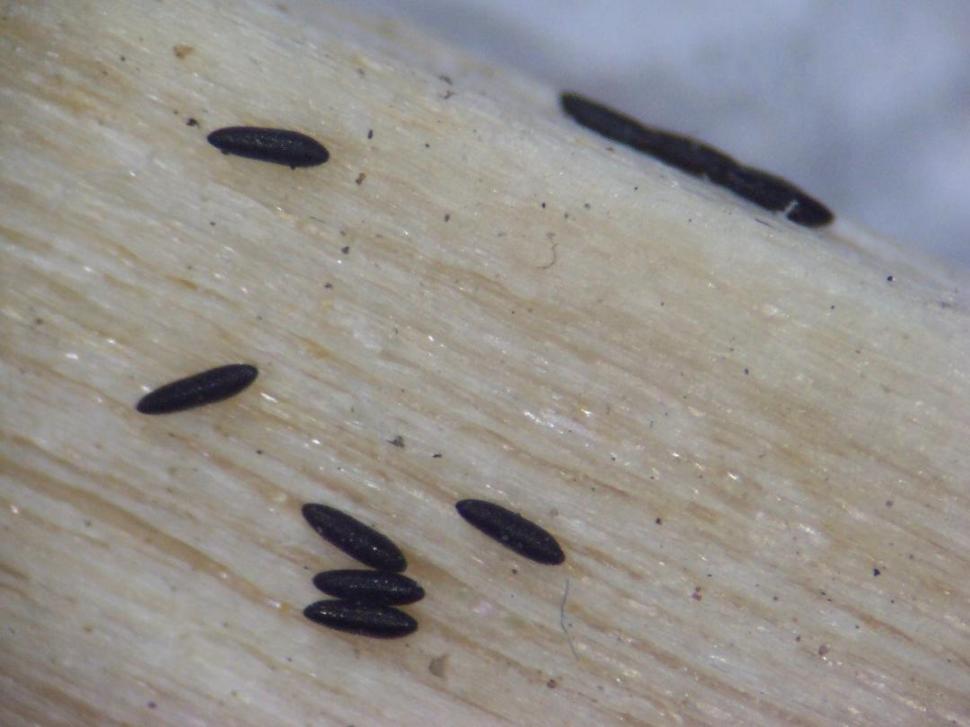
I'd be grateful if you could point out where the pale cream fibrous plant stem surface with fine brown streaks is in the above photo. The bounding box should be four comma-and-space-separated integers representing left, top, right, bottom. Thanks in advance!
0, 1, 970, 725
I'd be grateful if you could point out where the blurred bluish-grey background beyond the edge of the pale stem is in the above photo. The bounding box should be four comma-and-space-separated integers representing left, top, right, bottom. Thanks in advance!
348, 0, 970, 268
